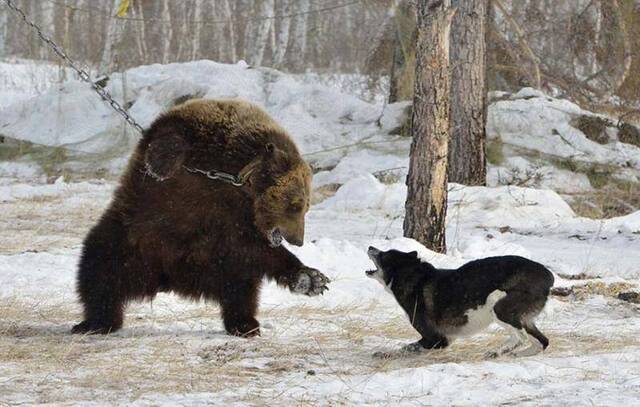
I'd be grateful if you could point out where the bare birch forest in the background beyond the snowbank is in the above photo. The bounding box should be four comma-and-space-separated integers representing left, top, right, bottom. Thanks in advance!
0, 0, 640, 106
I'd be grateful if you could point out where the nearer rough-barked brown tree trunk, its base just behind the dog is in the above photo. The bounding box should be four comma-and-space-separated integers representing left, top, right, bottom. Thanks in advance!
404, 0, 455, 253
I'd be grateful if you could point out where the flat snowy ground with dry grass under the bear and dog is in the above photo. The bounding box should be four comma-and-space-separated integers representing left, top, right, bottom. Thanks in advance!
0, 176, 640, 405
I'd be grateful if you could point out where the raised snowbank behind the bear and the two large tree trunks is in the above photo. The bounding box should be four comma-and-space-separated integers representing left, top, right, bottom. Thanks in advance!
0, 61, 640, 199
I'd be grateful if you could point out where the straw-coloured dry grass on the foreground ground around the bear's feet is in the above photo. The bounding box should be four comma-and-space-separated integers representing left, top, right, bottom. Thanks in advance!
0, 290, 640, 404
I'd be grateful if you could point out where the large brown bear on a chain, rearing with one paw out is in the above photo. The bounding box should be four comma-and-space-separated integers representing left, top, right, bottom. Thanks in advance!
72, 99, 329, 336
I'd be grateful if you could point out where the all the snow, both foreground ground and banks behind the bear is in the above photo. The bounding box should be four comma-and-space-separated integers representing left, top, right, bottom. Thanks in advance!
0, 61, 640, 406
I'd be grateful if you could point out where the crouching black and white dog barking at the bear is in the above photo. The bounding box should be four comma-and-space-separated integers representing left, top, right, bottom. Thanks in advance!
367, 247, 553, 357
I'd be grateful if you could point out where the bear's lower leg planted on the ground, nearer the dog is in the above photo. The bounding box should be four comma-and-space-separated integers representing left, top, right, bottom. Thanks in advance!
220, 280, 260, 338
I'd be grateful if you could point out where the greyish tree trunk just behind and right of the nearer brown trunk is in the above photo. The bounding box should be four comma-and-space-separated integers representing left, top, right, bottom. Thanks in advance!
448, 0, 487, 185
